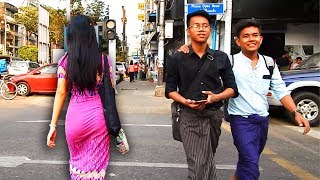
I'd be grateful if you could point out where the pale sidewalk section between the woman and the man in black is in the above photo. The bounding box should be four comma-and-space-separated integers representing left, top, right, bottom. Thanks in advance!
116, 79, 172, 114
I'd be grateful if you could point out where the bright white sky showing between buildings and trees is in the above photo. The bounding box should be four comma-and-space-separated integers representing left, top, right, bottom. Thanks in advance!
5, 0, 144, 55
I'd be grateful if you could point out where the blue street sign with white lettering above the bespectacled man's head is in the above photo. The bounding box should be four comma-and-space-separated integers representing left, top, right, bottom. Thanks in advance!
188, 3, 223, 15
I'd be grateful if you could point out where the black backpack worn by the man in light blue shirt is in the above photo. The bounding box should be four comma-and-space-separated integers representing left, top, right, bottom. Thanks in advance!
223, 55, 275, 122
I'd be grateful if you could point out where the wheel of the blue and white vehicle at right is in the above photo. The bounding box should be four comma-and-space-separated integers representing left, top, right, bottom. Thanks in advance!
289, 92, 320, 126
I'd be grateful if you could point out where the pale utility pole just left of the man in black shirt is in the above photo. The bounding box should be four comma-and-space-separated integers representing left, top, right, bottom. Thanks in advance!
155, 0, 165, 96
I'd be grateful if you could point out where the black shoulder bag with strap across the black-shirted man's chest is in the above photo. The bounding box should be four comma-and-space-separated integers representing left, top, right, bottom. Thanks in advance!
171, 55, 213, 142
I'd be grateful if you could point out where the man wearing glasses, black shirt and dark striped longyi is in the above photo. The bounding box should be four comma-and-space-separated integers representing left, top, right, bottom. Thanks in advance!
165, 10, 238, 180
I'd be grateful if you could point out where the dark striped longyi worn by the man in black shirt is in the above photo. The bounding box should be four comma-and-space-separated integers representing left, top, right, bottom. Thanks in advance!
179, 108, 223, 180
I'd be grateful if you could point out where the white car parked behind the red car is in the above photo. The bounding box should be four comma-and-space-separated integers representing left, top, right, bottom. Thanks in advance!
7, 61, 40, 75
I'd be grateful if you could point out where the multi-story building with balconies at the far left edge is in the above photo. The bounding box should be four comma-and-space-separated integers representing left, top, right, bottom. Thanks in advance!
0, 2, 22, 56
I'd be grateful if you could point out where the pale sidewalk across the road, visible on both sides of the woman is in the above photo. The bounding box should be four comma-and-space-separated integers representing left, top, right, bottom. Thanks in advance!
0, 79, 172, 114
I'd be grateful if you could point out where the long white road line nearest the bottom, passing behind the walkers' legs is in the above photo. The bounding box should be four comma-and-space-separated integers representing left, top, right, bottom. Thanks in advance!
0, 156, 244, 170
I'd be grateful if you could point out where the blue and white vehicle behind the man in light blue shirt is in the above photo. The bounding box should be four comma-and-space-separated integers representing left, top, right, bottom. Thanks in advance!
268, 53, 320, 126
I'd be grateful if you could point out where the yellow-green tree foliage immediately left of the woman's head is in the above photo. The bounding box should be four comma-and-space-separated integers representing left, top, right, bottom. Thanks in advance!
45, 6, 67, 46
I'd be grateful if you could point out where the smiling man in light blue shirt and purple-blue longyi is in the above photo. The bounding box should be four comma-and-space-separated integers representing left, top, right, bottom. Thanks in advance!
228, 19, 310, 180
